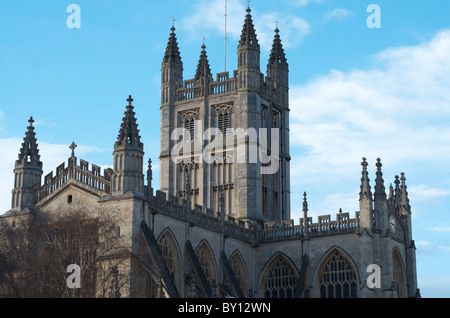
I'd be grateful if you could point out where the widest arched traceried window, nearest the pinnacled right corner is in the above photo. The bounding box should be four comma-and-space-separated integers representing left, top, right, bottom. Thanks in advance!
318, 250, 357, 298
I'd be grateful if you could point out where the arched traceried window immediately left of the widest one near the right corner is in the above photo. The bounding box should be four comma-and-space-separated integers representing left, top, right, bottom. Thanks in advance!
262, 255, 298, 298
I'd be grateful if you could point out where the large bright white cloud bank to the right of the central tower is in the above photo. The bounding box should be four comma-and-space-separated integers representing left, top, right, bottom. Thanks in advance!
290, 30, 450, 186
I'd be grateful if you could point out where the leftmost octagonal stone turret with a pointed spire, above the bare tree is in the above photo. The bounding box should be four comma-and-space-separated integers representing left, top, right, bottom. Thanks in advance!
11, 117, 43, 212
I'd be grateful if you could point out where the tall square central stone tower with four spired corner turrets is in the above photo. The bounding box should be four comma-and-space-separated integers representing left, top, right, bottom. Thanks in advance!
160, 8, 290, 223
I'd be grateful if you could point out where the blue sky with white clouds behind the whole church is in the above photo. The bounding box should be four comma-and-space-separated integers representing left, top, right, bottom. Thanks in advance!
0, 0, 450, 297
